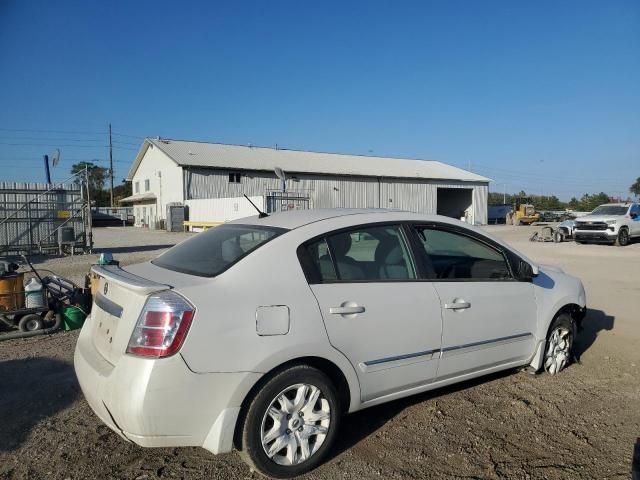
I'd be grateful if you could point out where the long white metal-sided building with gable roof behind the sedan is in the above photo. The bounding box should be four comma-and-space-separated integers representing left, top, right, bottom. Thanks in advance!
123, 138, 490, 228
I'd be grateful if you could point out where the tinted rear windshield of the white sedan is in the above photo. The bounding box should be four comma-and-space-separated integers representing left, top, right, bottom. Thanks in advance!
151, 225, 286, 277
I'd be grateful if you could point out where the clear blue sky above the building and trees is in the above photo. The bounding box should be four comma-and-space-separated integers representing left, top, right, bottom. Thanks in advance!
0, 0, 640, 200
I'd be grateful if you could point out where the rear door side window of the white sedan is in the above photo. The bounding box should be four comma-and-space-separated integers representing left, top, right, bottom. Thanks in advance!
303, 225, 416, 283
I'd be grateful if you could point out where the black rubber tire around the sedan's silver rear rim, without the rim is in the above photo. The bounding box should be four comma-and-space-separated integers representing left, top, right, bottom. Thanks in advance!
239, 365, 342, 478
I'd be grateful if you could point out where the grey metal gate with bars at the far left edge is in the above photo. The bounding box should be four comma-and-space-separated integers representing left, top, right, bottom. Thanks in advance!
0, 182, 91, 256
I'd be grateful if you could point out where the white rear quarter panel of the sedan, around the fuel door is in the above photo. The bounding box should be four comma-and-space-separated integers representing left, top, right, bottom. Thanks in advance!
176, 232, 360, 407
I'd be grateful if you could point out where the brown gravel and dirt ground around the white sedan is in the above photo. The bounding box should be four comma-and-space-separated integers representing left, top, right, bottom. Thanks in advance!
0, 226, 640, 480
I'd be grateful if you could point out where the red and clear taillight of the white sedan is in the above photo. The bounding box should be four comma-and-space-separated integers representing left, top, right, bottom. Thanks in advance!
127, 290, 195, 358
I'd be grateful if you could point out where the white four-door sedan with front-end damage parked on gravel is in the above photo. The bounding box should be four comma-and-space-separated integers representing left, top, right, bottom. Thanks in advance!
75, 210, 586, 478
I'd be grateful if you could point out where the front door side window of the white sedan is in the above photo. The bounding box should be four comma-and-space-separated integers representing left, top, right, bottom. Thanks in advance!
416, 227, 511, 280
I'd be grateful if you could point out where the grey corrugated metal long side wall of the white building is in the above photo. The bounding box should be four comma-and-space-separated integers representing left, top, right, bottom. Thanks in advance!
184, 168, 488, 224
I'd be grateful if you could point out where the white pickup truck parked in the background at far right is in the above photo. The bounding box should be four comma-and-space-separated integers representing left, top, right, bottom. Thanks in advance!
574, 203, 640, 247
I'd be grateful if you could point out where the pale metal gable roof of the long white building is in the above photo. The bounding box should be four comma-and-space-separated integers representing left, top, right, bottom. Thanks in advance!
127, 138, 490, 182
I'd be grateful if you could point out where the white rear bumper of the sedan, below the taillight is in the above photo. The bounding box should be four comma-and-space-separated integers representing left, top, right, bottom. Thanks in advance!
74, 318, 261, 453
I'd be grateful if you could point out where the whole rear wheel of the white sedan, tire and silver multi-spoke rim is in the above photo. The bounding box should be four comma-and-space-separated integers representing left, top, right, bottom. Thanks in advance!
240, 365, 341, 478
